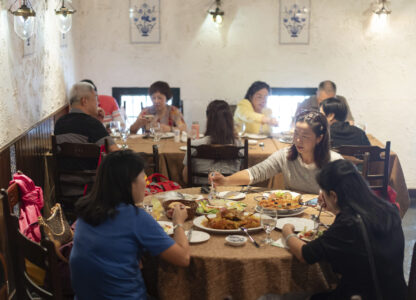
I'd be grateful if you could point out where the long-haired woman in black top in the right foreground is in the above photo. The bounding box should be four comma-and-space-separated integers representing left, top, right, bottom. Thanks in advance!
283, 160, 406, 300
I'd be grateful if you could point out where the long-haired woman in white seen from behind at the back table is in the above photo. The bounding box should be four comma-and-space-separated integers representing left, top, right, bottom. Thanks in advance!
182, 100, 241, 184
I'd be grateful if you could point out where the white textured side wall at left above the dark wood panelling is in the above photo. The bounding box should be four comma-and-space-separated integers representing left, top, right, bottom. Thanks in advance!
0, 0, 75, 148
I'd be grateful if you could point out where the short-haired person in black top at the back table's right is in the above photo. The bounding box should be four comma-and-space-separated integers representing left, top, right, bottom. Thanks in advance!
320, 98, 370, 147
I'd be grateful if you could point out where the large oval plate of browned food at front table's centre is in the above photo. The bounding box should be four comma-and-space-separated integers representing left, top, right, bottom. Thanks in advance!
194, 209, 262, 233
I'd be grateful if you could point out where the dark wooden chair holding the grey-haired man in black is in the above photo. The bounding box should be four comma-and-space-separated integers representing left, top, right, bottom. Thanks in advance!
52, 135, 100, 222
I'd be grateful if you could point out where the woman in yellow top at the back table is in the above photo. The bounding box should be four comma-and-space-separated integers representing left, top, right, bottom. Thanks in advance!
234, 81, 278, 135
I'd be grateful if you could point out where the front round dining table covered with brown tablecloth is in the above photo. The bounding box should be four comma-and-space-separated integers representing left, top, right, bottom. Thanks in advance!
142, 187, 334, 300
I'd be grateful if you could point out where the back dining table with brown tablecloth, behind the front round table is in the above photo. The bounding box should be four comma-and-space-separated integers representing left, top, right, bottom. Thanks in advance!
123, 134, 410, 218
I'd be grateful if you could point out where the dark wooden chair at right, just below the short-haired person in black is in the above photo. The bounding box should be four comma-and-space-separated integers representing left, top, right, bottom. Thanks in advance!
333, 141, 390, 199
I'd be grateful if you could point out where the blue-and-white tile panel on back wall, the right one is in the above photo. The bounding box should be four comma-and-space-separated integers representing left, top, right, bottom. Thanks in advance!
279, 0, 311, 44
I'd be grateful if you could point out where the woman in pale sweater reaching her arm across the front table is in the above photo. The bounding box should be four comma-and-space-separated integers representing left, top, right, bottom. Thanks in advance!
209, 111, 342, 194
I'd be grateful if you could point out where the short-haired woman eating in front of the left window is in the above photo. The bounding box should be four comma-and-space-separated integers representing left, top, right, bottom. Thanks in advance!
130, 81, 186, 133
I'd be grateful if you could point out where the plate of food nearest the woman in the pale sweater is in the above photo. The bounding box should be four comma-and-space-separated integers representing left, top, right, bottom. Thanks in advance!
256, 190, 306, 217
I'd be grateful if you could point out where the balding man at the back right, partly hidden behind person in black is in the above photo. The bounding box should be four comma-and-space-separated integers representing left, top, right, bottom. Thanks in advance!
295, 80, 354, 125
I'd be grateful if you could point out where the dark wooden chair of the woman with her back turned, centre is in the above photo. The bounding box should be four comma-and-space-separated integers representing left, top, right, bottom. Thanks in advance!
187, 138, 248, 187
